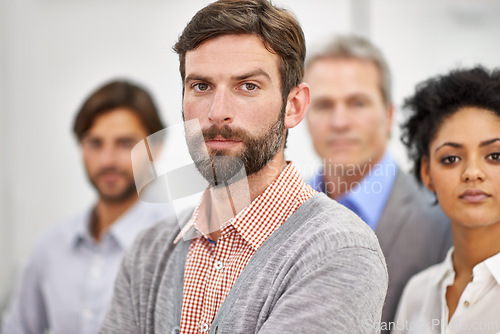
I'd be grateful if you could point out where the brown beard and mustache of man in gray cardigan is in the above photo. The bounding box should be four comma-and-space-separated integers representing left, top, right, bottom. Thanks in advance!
187, 108, 285, 187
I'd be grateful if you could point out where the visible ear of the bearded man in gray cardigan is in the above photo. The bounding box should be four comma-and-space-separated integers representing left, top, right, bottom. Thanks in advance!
285, 83, 311, 129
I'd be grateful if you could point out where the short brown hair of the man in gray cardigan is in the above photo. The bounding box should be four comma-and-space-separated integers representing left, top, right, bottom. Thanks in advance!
174, 0, 306, 101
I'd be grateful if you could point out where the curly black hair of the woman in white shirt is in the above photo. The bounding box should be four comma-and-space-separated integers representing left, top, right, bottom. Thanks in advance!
401, 66, 500, 183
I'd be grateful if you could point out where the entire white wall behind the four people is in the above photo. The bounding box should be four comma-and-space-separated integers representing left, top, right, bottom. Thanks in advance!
0, 0, 500, 305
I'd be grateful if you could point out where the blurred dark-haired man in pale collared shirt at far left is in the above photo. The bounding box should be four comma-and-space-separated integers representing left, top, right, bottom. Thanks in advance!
2, 81, 168, 334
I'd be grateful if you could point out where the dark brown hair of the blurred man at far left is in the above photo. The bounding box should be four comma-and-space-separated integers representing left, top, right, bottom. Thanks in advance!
73, 80, 165, 141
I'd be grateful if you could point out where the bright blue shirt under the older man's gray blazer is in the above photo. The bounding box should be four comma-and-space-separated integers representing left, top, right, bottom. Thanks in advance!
309, 152, 398, 231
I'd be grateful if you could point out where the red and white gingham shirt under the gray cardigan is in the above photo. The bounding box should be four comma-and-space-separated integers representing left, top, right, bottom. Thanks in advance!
175, 163, 316, 333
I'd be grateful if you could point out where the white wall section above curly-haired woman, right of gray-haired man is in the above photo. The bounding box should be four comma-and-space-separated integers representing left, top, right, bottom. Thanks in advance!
371, 0, 500, 167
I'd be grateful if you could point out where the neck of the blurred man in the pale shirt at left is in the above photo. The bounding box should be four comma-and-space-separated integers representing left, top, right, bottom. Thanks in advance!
90, 195, 138, 241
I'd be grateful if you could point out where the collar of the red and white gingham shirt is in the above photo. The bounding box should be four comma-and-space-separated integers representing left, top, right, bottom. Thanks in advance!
174, 162, 306, 249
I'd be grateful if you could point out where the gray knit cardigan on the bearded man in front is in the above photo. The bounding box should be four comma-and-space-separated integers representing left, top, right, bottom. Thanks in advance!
100, 194, 388, 334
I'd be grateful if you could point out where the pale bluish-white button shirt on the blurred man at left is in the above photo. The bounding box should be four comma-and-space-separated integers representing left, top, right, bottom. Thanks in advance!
2, 201, 171, 334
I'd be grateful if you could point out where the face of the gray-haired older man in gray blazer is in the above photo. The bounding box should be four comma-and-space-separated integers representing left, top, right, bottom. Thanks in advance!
305, 58, 392, 170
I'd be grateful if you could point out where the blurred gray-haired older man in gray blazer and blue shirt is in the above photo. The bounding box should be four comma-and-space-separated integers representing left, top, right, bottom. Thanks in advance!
305, 36, 452, 329
